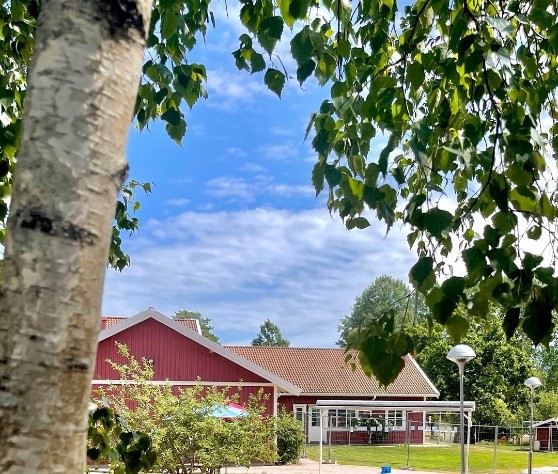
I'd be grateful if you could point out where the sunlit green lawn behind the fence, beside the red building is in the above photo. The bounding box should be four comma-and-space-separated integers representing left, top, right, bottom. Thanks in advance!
308, 445, 558, 474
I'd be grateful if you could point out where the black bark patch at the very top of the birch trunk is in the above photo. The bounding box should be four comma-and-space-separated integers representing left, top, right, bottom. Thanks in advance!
98, 0, 145, 38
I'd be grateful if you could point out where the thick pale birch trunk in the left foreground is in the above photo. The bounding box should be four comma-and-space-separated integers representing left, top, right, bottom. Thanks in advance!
0, 0, 151, 474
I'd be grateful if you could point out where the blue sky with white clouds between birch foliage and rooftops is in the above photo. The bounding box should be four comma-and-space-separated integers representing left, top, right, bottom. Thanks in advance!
103, 5, 420, 347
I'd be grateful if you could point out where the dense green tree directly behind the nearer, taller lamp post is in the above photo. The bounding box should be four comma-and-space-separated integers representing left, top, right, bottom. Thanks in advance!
409, 316, 536, 425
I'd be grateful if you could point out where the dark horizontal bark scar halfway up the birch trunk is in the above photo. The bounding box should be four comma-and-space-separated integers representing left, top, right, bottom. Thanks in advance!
15, 208, 97, 245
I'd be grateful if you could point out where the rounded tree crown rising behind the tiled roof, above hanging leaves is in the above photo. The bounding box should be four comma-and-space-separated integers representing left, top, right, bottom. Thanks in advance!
336, 275, 429, 347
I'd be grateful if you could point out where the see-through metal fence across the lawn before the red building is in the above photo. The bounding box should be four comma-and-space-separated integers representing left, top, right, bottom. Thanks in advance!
303, 410, 558, 474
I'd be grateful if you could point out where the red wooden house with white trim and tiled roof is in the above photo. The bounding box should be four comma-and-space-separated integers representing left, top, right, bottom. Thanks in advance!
93, 308, 439, 443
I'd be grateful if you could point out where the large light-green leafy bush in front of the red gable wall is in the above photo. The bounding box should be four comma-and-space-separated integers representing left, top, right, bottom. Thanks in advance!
100, 344, 277, 473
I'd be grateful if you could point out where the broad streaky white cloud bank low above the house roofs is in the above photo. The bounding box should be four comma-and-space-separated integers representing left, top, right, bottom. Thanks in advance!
103, 208, 414, 346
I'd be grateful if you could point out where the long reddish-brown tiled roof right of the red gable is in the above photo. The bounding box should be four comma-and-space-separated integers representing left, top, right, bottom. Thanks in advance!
226, 346, 438, 396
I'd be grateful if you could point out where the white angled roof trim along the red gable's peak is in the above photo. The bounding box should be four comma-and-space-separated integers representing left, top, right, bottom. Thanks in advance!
97, 308, 302, 395
